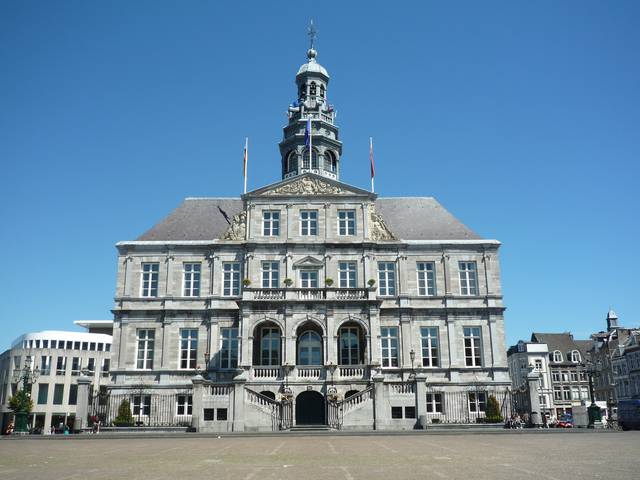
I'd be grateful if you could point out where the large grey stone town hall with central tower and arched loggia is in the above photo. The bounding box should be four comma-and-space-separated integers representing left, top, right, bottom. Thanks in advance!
106, 41, 510, 432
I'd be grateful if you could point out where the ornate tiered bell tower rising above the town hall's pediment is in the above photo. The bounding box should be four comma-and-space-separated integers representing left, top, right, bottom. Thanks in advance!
279, 22, 342, 180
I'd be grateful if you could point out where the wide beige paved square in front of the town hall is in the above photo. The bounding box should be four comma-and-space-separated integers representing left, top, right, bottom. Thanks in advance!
0, 432, 640, 480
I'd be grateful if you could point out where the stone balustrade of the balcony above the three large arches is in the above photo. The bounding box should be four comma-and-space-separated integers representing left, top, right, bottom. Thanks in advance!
242, 287, 377, 302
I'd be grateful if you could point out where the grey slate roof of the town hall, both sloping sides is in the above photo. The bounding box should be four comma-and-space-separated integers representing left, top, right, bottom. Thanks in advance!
137, 197, 481, 241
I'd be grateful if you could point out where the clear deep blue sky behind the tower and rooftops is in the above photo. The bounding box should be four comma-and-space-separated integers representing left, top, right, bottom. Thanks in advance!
0, 0, 640, 349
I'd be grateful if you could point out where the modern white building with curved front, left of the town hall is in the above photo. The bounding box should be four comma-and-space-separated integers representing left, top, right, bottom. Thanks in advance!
0, 320, 113, 433
